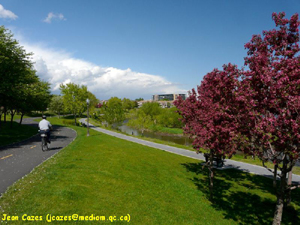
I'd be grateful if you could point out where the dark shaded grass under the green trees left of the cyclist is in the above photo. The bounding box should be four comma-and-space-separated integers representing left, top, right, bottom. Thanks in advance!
0, 121, 37, 146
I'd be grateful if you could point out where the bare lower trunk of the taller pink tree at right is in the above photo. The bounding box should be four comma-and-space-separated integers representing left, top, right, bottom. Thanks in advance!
273, 159, 287, 225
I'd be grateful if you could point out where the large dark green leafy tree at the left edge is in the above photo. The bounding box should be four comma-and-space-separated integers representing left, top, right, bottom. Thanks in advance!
0, 26, 47, 125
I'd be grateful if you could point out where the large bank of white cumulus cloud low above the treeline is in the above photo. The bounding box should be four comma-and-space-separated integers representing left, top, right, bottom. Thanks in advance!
21, 42, 186, 99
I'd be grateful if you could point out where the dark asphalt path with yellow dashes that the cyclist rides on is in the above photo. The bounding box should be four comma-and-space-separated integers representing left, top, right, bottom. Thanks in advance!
0, 118, 77, 195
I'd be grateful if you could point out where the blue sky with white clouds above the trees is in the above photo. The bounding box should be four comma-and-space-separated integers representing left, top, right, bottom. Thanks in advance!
0, 0, 300, 100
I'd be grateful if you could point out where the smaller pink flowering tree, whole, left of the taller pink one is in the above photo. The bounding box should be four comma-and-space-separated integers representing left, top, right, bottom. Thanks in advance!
174, 64, 240, 200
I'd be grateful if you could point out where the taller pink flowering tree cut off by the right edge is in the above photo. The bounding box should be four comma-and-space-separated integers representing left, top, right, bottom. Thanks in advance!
238, 13, 300, 224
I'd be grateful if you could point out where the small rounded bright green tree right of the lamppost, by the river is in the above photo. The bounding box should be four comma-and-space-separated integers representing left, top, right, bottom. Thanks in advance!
101, 97, 125, 124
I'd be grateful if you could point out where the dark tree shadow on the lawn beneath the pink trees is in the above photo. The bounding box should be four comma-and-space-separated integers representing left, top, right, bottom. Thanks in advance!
182, 163, 300, 224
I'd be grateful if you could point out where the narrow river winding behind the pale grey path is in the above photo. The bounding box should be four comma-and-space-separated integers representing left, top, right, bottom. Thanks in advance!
113, 121, 192, 146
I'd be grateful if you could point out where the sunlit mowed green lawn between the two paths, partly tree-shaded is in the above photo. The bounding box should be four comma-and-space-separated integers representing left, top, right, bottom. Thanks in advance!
0, 119, 300, 224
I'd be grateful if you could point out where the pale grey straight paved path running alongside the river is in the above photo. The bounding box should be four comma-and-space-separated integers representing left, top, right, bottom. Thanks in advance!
80, 119, 300, 182
